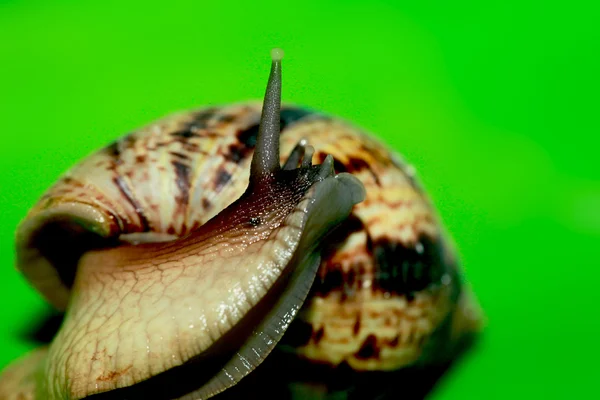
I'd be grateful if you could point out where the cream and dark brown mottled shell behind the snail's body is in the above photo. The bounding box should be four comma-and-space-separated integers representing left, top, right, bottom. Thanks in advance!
17, 103, 477, 388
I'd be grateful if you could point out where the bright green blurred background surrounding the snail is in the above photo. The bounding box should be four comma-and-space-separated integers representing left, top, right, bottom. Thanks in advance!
0, 0, 600, 399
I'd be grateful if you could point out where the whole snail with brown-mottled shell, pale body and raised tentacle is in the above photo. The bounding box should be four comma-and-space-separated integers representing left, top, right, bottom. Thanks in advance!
0, 49, 481, 400
